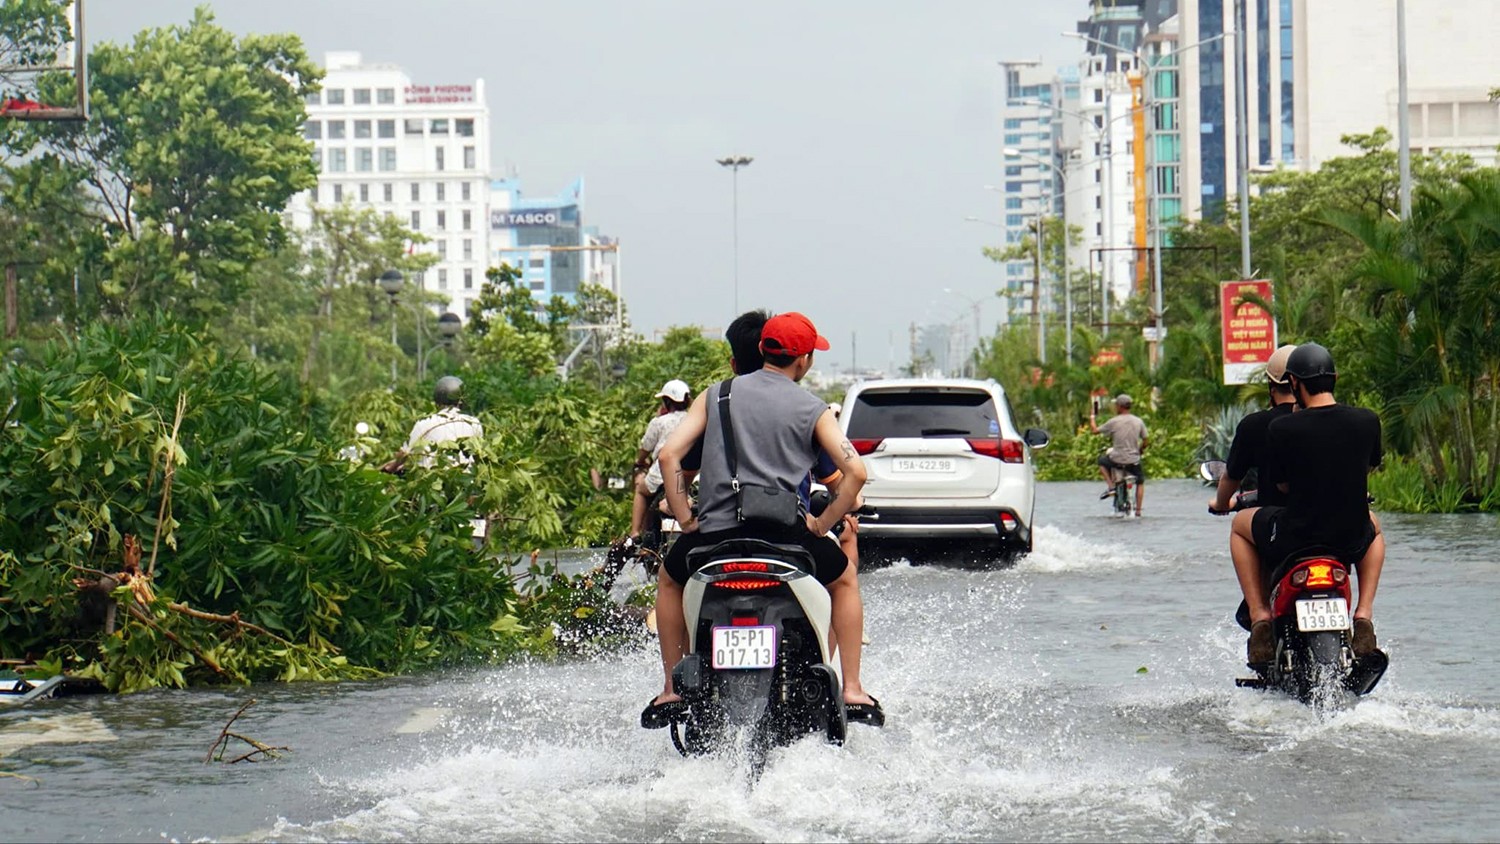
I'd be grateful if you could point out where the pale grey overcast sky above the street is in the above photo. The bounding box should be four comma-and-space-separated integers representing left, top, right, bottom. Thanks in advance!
87, 0, 1089, 373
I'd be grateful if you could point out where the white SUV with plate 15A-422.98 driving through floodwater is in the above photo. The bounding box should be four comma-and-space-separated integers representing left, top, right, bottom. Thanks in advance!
840, 378, 1050, 561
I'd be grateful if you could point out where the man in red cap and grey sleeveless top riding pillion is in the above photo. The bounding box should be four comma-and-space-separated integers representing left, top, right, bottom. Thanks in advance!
641, 312, 885, 727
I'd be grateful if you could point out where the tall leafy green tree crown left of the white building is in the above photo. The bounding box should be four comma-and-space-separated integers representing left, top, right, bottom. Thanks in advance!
12, 7, 321, 318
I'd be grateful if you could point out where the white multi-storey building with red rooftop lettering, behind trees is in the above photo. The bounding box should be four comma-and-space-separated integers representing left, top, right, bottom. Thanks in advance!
290, 52, 491, 316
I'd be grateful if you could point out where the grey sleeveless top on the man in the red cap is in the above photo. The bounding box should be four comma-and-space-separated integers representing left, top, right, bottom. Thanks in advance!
698, 369, 828, 532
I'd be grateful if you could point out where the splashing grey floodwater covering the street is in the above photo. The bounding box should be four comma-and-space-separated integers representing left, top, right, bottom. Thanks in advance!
0, 481, 1500, 841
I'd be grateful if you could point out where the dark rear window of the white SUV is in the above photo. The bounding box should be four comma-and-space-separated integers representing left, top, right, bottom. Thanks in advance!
845, 390, 1001, 439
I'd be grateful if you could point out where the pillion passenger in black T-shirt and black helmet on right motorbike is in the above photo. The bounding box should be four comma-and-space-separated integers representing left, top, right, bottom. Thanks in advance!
1230, 343, 1386, 664
